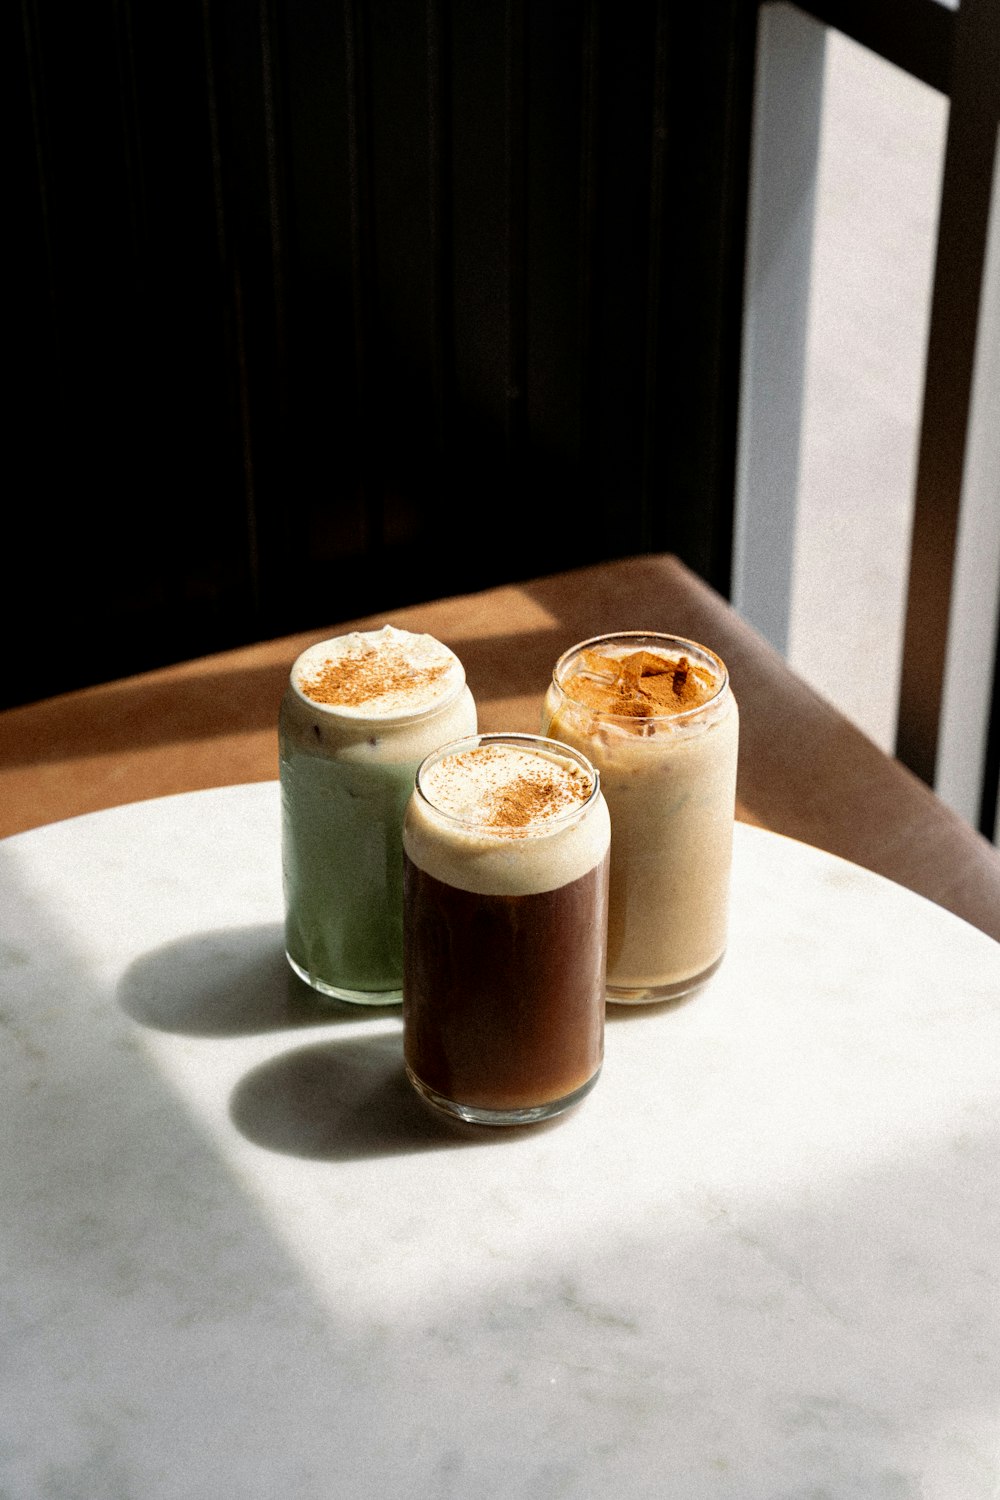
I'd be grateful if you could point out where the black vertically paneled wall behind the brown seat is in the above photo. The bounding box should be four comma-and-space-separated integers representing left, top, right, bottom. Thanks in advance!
3, 0, 756, 705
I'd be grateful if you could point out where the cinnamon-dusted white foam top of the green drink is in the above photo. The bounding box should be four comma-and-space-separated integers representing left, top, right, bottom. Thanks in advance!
291, 626, 465, 719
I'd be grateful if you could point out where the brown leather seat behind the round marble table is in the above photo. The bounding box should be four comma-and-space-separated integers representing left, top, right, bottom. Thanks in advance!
0, 555, 1000, 941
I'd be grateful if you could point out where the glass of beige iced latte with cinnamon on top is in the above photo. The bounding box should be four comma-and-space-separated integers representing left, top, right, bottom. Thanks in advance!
543, 632, 739, 1004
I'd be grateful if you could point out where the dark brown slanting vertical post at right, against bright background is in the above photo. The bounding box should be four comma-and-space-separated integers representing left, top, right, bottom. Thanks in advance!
897, 0, 1000, 786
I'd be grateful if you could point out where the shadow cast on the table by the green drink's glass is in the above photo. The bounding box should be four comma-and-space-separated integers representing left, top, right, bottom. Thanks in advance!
118, 923, 389, 1037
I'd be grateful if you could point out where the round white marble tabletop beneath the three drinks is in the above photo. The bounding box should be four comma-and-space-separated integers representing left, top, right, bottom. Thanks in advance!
0, 783, 1000, 1500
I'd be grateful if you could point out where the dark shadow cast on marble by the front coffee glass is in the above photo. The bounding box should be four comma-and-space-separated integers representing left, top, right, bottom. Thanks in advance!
229, 1032, 559, 1161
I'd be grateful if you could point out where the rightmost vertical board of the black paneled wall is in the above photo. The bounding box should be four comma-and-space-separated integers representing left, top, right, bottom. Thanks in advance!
640, 0, 757, 594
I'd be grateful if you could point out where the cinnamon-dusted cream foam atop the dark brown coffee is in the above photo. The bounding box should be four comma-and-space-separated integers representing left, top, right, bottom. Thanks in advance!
403, 737, 610, 896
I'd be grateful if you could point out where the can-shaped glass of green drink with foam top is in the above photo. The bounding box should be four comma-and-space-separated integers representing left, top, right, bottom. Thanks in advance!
279, 626, 477, 1005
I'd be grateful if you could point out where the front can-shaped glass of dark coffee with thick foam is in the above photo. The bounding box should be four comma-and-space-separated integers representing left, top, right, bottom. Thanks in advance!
403, 735, 610, 1125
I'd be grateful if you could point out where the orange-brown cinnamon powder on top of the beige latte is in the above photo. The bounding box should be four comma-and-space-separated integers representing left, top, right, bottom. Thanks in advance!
562, 651, 718, 719
